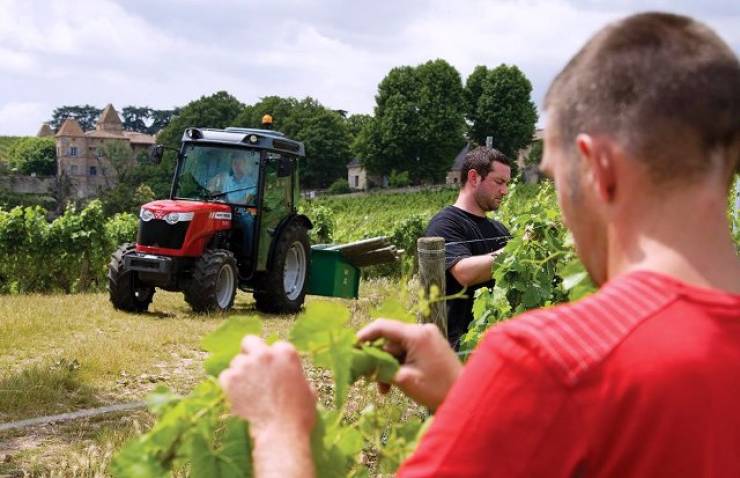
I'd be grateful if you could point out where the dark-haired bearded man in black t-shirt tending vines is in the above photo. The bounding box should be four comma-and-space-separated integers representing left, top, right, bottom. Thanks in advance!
424, 146, 511, 349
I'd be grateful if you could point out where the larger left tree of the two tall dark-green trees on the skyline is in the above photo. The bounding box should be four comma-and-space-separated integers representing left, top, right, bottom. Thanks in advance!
353, 60, 465, 183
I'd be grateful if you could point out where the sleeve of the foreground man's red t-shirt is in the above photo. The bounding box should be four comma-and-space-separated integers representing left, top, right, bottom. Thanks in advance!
398, 329, 579, 477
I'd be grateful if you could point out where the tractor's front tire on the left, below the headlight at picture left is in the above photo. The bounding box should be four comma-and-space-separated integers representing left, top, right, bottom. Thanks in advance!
108, 243, 154, 312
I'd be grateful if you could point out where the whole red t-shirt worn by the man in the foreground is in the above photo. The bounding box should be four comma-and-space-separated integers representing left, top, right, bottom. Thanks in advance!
399, 272, 740, 478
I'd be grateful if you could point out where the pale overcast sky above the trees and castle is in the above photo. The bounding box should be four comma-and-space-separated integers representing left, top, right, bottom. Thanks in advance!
0, 0, 740, 135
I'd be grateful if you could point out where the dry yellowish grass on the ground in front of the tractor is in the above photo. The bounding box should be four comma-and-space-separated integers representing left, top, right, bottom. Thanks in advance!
0, 279, 406, 477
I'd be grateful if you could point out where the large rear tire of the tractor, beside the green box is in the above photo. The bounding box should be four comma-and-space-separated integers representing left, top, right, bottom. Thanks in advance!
254, 223, 311, 314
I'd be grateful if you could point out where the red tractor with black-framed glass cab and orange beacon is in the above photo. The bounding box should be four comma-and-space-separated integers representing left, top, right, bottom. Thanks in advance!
108, 128, 312, 313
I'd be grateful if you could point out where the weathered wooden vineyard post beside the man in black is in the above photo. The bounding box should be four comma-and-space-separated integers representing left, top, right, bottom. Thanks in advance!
416, 237, 447, 337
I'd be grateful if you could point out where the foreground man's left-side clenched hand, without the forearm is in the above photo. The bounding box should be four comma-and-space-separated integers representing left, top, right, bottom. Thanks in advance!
219, 335, 316, 440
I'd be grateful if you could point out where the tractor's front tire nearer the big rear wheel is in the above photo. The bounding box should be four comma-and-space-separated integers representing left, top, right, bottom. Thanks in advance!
184, 249, 239, 312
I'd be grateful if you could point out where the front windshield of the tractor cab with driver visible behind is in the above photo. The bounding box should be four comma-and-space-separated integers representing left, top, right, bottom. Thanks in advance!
175, 144, 260, 206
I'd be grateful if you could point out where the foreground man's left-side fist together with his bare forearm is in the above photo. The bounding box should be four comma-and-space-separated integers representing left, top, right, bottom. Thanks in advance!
219, 335, 316, 477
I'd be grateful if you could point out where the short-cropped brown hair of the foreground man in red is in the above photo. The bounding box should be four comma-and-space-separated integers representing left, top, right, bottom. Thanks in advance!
545, 13, 740, 184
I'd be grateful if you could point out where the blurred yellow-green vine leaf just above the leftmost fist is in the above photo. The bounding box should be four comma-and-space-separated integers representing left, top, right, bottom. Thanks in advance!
202, 316, 262, 377
